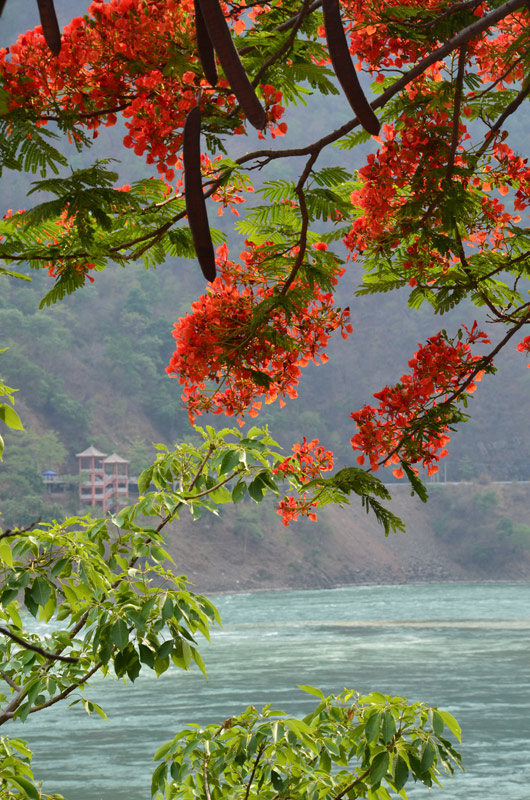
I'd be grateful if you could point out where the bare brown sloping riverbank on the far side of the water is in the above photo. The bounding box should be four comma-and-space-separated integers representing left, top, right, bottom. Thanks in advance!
162, 484, 530, 593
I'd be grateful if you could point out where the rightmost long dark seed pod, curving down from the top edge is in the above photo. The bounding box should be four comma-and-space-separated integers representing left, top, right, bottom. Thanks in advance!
322, 0, 381, 136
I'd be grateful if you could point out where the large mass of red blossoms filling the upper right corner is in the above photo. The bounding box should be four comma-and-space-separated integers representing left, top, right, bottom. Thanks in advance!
338, 0, 530, 286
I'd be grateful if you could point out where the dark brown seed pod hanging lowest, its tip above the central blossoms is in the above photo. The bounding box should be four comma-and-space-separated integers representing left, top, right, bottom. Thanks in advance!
182, 106, 217, 281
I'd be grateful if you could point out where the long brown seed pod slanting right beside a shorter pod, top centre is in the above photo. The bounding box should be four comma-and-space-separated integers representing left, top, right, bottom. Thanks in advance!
198, 0, 267, 131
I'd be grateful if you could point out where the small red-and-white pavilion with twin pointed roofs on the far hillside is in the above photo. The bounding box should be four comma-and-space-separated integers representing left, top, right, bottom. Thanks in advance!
76, 445, 129, 514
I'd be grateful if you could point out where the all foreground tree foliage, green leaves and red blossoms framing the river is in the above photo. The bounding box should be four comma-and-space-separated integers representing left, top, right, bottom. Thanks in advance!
0, 0, 530, 800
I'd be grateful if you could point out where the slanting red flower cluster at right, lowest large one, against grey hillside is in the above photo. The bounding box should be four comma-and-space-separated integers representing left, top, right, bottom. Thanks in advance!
350, 322, 489, 478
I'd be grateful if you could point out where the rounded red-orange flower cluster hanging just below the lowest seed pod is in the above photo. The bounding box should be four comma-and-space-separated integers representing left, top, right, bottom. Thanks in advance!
166, 242, 352, 421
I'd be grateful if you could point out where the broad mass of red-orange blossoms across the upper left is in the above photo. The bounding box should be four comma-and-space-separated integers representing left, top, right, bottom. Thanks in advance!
0, 0, 287, 181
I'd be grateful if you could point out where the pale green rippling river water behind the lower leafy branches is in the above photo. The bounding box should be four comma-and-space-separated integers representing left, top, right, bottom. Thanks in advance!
10, 583, 530, 800
